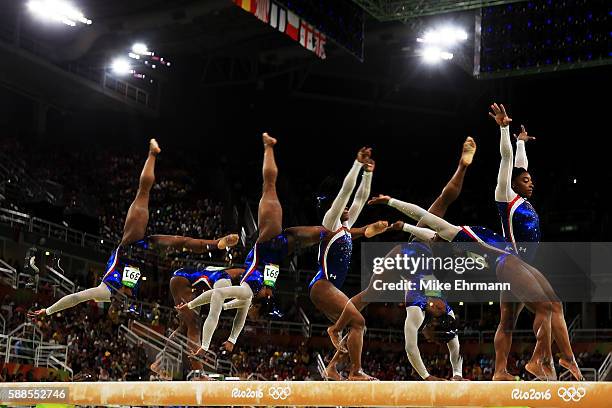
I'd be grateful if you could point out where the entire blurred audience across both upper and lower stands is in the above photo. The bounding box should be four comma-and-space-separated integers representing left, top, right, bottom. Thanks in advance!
0, 140, 604, 381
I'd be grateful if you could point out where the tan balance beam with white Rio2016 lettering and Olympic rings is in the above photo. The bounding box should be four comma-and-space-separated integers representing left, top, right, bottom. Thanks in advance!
0, 381, 612, 408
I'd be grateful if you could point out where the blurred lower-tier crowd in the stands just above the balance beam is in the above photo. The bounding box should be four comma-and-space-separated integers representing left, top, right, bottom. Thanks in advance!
0, 286, 605, 381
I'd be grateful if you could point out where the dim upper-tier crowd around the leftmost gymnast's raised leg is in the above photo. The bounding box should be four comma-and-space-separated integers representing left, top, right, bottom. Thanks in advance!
0, 139, 226, 243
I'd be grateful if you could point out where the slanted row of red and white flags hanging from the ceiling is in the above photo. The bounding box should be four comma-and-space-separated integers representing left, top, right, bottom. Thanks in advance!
234, 0, 327, 59
